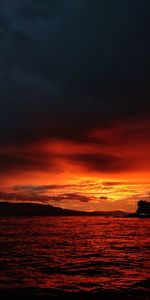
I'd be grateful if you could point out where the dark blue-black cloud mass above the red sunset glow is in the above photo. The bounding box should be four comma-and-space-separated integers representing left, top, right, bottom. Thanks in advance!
0, 0, 150, 145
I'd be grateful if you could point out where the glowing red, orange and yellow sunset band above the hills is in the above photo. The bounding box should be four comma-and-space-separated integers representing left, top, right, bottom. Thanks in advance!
1, 116, 150, 211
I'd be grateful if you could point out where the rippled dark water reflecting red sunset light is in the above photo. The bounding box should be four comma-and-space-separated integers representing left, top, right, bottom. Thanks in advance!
0, 217, 150, 300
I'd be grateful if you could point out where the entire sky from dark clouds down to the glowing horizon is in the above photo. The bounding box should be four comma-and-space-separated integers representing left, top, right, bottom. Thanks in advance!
0, 0, 150, 211
